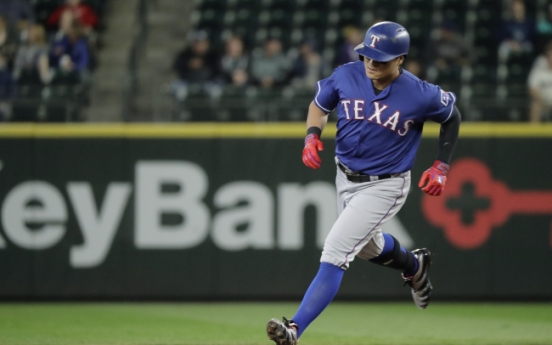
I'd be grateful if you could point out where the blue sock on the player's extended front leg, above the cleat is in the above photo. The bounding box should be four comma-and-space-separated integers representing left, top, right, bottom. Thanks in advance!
292, 262, 345, 338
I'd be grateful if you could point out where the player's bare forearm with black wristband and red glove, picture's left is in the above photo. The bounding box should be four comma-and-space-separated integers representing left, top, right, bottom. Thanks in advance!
303, 101, 328, 169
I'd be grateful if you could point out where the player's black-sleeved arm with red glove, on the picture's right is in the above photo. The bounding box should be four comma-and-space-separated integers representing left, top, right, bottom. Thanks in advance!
418, 105, 462, 196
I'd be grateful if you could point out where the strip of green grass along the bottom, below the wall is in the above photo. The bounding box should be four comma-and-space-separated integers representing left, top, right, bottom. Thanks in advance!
0, 302, 552, 345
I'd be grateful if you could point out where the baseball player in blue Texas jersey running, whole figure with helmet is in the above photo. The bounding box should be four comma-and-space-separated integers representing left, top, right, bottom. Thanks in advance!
267, 22, 461, 345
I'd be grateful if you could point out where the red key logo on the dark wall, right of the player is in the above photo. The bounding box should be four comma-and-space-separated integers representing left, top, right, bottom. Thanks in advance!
422, 158, 552, 249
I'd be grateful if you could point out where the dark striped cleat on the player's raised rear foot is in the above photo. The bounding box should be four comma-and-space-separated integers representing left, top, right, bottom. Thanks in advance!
403, 248, 433, 309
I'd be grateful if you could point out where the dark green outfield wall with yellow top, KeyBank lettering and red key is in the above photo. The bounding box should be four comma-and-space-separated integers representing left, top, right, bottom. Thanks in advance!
0, 124, 552, 300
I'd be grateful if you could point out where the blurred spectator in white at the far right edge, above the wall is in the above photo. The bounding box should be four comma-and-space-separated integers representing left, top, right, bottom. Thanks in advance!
527, 41, 552, 123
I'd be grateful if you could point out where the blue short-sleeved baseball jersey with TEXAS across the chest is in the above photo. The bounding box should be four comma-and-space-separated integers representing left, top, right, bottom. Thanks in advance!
314, 61, 456, 175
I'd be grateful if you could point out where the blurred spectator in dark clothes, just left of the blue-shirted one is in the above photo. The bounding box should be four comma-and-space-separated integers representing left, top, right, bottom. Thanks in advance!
13, 24, 50, 84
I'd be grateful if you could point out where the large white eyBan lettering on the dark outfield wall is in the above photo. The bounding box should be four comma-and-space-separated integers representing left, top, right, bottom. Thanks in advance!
0, 161, 337, 268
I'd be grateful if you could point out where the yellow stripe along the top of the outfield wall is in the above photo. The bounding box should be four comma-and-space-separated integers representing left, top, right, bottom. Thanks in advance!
0, 122, 552, 139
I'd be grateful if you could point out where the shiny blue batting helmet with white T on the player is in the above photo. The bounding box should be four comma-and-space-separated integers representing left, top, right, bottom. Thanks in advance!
355, 22, 410, 62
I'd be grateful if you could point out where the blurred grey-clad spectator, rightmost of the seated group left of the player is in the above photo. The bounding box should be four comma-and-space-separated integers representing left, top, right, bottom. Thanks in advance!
291, 39, 323, 89
